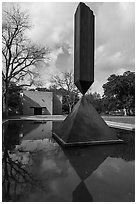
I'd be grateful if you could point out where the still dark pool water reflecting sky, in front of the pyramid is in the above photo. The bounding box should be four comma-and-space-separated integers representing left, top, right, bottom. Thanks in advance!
3, 121, 135, 202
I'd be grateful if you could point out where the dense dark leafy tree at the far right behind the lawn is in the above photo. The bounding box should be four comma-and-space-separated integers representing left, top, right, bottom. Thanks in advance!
103, 71, 135, 114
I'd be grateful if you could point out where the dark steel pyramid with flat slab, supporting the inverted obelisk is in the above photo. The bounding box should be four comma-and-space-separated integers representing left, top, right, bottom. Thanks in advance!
53, 96, 123, 147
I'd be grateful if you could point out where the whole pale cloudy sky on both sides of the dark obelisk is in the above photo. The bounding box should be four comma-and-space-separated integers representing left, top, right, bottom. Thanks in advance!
3, 2, 135, 94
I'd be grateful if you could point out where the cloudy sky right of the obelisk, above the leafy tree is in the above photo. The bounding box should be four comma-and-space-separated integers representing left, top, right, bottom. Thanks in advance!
91, 2, 135, 93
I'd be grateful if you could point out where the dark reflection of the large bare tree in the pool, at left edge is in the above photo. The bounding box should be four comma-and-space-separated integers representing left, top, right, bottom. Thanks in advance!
2, 121, 43, 201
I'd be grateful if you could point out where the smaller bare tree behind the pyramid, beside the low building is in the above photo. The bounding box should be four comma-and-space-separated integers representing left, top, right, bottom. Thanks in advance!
50, 72, 79, 112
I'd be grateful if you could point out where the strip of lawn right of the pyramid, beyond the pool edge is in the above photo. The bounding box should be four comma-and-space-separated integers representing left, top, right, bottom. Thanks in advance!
102, 116, 135, 124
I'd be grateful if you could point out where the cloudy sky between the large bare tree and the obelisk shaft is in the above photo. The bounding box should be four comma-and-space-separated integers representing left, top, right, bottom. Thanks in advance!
21, 3, 77, 85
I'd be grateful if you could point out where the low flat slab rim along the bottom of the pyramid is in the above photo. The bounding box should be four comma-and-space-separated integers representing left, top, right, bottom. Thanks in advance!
53, 133, 125, 147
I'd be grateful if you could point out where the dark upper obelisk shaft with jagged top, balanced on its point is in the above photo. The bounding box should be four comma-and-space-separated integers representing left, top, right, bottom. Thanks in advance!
74, 3, 94, 94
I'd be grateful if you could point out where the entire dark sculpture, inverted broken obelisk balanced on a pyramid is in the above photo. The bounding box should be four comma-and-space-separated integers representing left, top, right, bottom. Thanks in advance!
53, 3, 123, 147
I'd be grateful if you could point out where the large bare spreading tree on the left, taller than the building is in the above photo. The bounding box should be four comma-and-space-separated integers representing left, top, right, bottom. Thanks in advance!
2, 6, 49, 115
